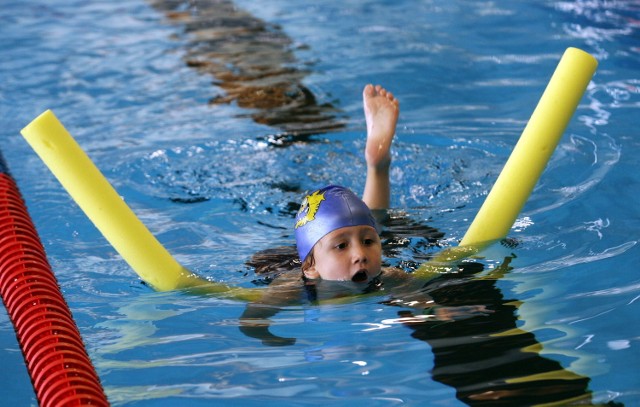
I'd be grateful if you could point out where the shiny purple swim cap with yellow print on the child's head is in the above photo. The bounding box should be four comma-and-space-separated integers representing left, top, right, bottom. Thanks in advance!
295, 185, 378, 261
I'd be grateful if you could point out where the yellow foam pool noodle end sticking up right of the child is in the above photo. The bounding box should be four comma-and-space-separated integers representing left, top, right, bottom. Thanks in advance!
417, 48, 598, 273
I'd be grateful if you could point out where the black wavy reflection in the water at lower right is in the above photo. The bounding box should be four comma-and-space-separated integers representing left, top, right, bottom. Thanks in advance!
398, 259, 619, 406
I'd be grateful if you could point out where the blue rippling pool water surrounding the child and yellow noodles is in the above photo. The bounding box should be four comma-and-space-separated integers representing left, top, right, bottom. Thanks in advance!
0, 0, 640, 406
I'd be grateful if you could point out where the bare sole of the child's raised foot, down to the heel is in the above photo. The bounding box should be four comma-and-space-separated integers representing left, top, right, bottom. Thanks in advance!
362, 85, 400, 168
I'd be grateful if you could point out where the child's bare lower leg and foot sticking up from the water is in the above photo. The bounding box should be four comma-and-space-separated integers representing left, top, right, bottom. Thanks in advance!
362, 85, 400, 209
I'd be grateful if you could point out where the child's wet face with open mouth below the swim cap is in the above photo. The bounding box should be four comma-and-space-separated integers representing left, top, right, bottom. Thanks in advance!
304, 226, 382, 283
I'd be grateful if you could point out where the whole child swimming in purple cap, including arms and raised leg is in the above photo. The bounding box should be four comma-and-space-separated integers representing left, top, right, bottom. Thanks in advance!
240, 85, 491, 346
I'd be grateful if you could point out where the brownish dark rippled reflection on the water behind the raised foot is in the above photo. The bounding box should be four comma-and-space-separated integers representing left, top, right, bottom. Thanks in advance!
149, 0, 344, 138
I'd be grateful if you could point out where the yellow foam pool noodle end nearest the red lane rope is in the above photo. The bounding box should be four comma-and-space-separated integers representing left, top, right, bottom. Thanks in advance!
21, 110, 208, 291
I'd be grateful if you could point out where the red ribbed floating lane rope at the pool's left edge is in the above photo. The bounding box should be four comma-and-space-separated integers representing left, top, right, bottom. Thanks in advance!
0, 155, 109, 407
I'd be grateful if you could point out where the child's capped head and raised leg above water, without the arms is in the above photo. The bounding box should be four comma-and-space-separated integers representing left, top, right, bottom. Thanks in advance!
295, 84, 400, 283
